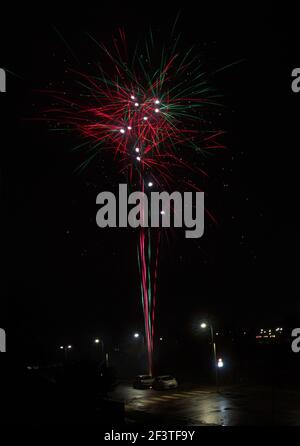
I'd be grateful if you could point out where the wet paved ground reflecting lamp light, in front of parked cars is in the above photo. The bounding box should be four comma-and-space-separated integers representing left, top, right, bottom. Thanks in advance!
111, 384, 300, 426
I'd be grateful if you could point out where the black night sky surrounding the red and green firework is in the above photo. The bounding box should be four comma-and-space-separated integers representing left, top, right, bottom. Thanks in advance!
0, 2, 300, 354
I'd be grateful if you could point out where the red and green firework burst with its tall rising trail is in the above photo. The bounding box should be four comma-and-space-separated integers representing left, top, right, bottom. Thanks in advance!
48, 24, 223, 374
